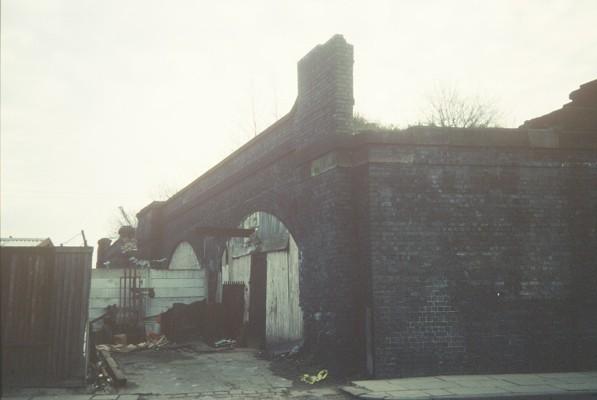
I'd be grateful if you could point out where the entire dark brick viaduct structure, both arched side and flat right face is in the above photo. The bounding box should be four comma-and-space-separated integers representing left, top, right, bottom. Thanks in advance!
138, 36, 597, 377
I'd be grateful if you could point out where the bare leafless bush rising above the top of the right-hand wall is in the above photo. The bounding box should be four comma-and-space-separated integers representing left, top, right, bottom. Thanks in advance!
423, 86, 500, 128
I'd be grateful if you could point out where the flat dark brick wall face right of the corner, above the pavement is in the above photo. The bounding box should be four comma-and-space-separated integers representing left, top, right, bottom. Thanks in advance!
368, 139, 597, 376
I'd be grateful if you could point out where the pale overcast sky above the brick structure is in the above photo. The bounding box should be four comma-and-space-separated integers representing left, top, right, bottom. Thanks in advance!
0, 0, 597, 250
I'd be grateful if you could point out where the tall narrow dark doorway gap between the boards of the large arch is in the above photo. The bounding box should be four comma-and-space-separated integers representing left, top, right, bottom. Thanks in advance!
248, 253, 267, 348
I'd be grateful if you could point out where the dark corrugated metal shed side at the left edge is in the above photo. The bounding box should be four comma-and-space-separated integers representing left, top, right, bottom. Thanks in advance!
0, 247, 93, 387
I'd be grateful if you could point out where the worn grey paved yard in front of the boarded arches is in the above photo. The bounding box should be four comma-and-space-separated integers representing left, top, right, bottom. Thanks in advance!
3, 342, 351, 400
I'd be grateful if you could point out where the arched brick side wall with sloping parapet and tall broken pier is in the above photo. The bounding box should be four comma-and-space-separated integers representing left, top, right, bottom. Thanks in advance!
138, 36, 355, 367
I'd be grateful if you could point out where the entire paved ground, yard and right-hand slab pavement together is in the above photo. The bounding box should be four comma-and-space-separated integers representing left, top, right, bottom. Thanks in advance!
2, 343, 597, 400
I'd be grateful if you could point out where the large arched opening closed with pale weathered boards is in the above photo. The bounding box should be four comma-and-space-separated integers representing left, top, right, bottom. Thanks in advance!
216, 211, 303, 350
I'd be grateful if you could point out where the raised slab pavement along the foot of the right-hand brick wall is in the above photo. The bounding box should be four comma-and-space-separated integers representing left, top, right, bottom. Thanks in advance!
342, 371, 597, 400
